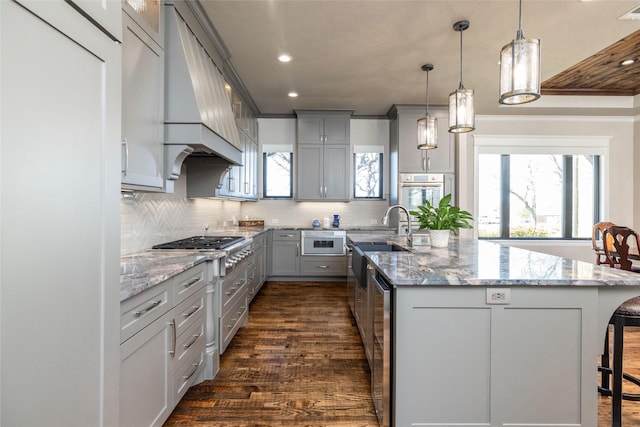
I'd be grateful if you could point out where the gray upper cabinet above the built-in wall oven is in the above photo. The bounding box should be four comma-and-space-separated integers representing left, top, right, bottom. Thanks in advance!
389, 106, 455, 173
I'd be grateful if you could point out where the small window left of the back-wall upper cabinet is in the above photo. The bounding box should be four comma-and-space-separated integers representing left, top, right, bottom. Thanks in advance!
262, 151, 293, 199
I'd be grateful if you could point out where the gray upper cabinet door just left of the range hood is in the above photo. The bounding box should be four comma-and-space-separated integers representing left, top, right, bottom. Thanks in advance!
122, 13, 164, 190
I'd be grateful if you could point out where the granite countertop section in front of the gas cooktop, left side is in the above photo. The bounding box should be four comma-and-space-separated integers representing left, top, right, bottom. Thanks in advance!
120, 250, 225, 302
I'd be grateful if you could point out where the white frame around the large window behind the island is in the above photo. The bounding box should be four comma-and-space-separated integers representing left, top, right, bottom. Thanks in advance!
474, 135, 611, 241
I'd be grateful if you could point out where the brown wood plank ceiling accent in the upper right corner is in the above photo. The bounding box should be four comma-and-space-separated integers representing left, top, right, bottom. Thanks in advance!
541, 30, 640, 96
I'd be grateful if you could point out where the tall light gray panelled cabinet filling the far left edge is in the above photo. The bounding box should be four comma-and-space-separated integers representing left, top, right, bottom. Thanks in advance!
0, 1, 122, 427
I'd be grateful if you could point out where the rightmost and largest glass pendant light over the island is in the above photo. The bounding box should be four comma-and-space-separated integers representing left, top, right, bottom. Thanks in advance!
499, 0, 540, 105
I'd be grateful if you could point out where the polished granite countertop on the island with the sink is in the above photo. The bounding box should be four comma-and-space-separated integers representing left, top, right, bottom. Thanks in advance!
348, 234, 640, 286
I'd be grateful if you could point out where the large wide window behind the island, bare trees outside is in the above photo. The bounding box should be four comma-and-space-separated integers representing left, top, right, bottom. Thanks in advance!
476, 138, 604, 239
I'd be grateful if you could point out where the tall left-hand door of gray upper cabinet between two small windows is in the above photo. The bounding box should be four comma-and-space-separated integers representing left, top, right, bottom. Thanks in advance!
297, 144, 324, 200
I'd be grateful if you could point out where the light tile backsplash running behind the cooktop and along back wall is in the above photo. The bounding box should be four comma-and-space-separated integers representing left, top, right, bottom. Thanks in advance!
120, 174, 389, 255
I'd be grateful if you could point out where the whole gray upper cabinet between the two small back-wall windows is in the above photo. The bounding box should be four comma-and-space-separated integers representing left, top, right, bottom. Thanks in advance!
296, 111, 351, 201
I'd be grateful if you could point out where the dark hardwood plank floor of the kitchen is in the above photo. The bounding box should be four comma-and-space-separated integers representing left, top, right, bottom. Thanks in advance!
165, 282, 640, 427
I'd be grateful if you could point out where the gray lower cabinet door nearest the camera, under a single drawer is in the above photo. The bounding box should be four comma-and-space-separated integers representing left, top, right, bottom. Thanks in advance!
119, 311, 174, 427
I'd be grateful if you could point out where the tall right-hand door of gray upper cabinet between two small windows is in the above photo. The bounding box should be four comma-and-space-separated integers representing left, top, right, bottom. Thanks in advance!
323, 145, 350, 201
